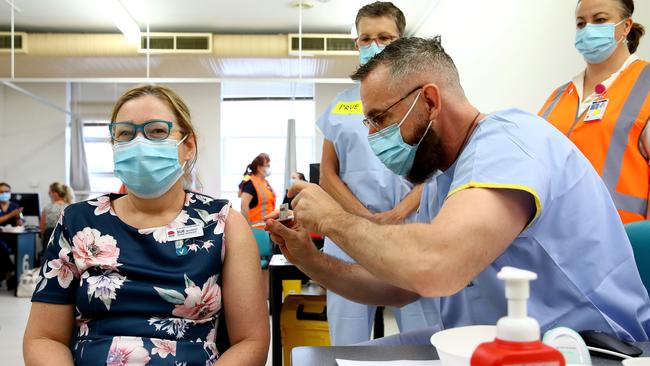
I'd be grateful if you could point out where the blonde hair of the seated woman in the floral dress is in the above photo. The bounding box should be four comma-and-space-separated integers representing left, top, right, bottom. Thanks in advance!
111, 84, 200, 188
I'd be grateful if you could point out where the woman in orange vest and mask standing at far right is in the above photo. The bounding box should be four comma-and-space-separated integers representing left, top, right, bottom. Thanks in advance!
539, 0, 650, 223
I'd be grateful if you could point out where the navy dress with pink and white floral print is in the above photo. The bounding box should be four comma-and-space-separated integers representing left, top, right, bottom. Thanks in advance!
32, 192, 230, 366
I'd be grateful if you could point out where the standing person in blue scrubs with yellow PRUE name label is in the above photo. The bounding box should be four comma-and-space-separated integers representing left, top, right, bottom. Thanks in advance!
318, 1, 437, 346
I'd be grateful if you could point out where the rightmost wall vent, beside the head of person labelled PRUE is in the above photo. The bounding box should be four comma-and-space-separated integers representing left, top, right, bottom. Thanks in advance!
289, 33, 358, 56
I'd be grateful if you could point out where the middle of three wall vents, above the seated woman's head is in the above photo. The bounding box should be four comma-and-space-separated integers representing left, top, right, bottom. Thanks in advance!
138, 32, 212, 53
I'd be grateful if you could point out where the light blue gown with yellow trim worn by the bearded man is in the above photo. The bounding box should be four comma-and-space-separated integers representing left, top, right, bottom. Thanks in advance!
418, 109, 650, 341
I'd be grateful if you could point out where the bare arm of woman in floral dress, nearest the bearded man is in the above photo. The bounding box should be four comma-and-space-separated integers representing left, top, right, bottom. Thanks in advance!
223, 210, 269, 347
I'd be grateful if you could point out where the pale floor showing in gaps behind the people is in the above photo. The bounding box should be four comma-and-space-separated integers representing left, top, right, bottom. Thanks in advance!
0, 289, 397, 366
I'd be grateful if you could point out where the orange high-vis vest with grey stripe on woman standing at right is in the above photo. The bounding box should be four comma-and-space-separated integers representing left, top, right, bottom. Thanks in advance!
539, 60, 650, 223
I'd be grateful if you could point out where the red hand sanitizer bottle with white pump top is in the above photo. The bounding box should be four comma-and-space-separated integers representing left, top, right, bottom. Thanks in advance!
470, 267, 565, 366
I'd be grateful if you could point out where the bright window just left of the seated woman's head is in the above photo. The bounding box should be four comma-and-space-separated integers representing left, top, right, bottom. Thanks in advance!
84, 120, 122, 197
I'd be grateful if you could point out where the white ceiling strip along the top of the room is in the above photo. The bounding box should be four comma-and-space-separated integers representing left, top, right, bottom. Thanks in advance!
0, 0, 438, 34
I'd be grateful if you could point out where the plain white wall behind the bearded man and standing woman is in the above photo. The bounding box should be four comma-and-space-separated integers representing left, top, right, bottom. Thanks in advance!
417, 0, 650, 113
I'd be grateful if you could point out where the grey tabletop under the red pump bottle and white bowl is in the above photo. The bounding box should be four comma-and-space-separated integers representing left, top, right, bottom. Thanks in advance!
291, 342, 650, 366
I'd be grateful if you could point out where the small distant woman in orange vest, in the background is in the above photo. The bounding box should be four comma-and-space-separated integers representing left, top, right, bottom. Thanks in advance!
241, 154, 275, 225
